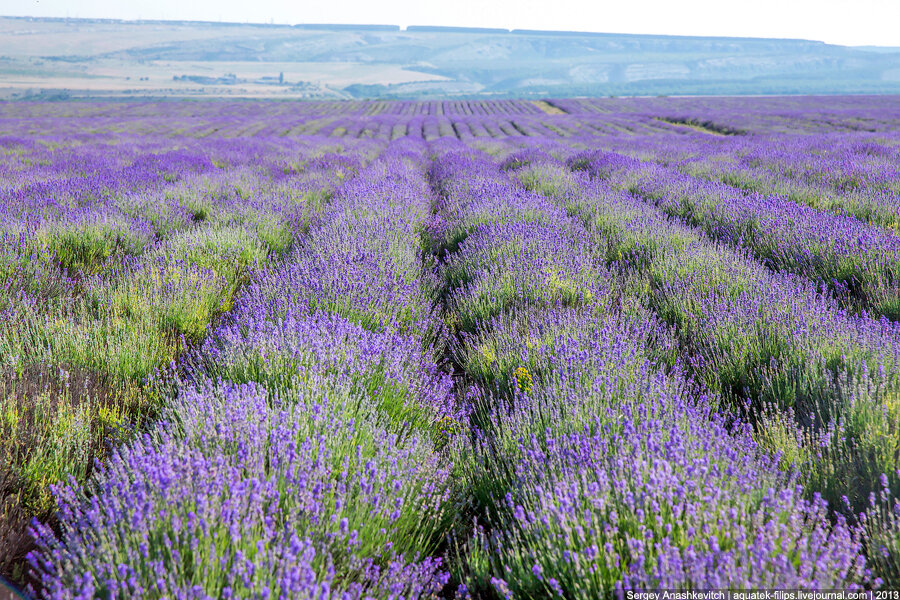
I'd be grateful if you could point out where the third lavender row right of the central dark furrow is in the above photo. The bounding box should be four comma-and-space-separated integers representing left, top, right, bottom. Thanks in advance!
573, 147, 900, 319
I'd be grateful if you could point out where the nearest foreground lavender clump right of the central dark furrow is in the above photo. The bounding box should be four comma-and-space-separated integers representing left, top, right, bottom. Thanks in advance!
488, 414, 865, 597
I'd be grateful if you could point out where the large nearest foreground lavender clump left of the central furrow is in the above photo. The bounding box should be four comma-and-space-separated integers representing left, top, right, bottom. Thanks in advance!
32, 381, 448, 599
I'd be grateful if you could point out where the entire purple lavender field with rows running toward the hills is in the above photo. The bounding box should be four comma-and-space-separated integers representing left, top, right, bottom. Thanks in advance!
0, 97, 900, 600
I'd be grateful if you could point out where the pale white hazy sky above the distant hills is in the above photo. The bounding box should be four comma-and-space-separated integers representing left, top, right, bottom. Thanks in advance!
7, 0, 900, 46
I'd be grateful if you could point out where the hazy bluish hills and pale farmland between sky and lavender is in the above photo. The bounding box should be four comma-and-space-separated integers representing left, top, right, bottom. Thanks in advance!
0, 17, 900, 99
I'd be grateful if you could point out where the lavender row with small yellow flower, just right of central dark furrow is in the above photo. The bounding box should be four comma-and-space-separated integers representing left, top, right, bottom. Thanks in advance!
432, 148, 869, 598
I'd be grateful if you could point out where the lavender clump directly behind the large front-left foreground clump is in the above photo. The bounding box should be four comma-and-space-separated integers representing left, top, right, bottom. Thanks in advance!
195, 310, 456, 426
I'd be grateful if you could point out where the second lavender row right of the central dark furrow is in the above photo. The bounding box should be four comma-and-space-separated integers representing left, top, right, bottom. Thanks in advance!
506, 146, 900, 581
